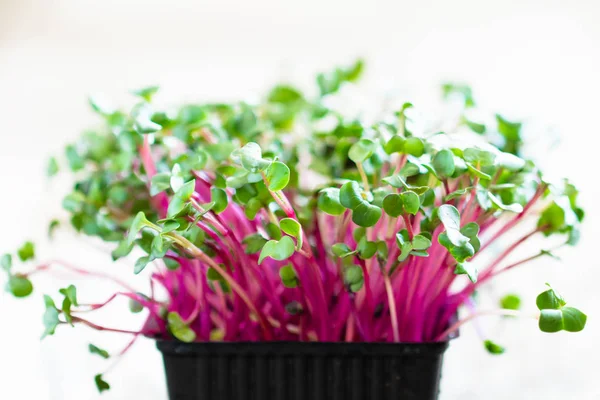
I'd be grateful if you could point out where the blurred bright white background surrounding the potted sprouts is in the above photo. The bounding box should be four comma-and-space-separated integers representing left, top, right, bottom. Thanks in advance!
0, 0, 600, 400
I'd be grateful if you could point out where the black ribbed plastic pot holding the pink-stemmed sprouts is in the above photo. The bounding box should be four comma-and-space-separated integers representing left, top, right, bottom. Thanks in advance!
157, 341, 448, 400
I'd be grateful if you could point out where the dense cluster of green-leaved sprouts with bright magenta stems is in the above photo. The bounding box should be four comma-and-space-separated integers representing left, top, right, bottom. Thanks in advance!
1, 62, 586, 390
